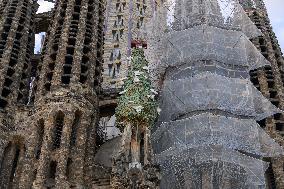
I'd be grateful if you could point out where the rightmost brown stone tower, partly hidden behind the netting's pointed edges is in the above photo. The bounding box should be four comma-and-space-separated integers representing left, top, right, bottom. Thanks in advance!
240, 0, 284, 188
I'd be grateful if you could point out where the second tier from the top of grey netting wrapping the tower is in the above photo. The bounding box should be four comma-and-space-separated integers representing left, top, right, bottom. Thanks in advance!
156, 25, 269, 70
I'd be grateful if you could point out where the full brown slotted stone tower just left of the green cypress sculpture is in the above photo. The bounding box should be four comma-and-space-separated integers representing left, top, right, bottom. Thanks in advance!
19, 0, 104, 189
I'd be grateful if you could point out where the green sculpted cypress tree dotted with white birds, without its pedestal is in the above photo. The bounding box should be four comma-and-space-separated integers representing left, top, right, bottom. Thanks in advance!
116, 48, 159, 127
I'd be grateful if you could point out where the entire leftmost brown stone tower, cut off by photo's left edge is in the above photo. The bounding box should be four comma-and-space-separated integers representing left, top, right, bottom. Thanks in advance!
0, 0, 37, 189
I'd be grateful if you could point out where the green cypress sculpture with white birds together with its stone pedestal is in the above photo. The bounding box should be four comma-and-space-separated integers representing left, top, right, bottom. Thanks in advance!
112, 45, 160, 189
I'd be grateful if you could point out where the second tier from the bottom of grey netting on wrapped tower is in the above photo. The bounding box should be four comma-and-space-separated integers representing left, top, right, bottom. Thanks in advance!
152, 113, 284, 157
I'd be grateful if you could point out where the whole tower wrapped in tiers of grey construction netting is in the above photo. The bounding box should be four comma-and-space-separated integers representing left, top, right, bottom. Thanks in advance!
148, 0, 283, 189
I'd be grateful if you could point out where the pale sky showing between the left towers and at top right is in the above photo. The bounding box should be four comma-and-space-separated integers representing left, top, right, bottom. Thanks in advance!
33, 0, 284, 52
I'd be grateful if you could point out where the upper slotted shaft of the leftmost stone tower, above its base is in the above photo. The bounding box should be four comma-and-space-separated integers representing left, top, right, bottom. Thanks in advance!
0, 0, 37, 112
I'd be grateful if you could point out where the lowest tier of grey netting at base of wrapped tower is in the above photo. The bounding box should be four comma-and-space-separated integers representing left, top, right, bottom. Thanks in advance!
157, 146, 268, 189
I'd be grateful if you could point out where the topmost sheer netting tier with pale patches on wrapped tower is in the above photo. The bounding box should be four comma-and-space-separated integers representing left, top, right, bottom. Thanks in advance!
160, 0, 261, 38
